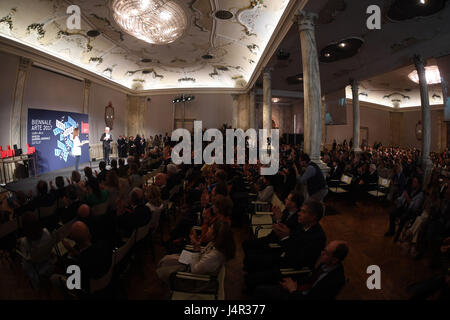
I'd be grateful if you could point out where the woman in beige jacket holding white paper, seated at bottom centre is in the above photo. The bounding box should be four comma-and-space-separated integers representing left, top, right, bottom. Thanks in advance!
156, 221, 236, 284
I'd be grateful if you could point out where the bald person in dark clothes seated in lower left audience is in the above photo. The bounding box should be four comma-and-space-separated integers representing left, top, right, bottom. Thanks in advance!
58, 221, 112, 293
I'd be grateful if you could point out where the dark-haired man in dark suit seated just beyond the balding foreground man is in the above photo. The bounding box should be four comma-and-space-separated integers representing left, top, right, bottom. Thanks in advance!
244, 200, 326, 290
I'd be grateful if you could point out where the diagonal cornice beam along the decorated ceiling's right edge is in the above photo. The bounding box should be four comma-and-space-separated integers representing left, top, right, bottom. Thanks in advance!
245, 0, 308, 91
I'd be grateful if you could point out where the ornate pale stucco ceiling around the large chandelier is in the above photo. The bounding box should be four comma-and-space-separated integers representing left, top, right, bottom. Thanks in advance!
0, 0, 293, 90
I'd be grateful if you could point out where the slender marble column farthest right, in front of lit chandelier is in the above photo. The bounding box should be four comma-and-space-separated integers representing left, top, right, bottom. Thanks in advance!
414, 55, 432, 186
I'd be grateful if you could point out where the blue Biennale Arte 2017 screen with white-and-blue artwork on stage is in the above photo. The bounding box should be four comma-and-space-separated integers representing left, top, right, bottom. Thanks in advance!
27, 109, 89, 174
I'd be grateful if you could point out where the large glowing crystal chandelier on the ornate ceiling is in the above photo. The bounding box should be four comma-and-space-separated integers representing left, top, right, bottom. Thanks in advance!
111, 0, 187, 44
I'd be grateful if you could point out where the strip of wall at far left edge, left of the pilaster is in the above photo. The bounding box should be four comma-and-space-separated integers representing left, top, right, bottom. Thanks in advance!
0, 52, 19, 150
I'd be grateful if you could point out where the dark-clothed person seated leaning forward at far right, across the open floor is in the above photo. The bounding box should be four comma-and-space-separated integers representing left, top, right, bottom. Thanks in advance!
385, 177, 424, 241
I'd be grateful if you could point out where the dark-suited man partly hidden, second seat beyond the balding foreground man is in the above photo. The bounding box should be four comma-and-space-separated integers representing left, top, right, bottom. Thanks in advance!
242, 192, 303, 255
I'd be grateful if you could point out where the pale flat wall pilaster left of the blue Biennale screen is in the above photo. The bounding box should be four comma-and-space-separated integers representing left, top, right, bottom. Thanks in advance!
11, 57, 32, 151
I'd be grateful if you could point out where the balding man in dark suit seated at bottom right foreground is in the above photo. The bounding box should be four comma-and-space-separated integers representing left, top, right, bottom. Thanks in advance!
253, 240, 348, 300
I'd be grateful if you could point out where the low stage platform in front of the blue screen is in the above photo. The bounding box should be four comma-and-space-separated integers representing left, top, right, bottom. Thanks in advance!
3, 161, 101, 193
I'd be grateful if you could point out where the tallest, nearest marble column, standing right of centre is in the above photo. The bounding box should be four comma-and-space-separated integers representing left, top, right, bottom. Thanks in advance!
296, 11, 328, 172
